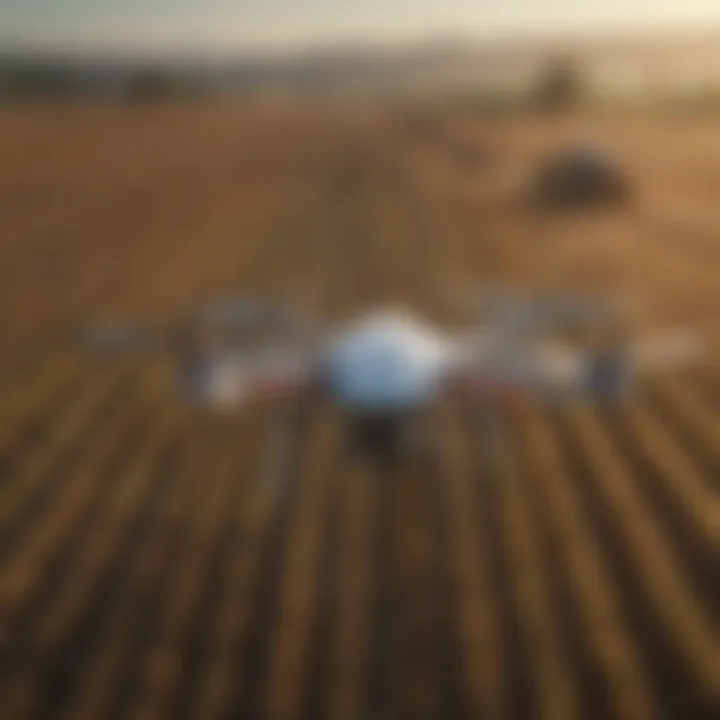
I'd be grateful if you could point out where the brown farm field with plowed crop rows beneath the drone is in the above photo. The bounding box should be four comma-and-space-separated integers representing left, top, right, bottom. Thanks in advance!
0, 106, 720, 720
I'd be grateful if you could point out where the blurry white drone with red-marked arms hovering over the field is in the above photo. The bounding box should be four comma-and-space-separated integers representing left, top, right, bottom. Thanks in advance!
83, 289, 704, 462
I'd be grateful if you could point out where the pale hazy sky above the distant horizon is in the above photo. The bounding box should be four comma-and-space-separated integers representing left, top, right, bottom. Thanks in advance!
0, 0, 720, 50
